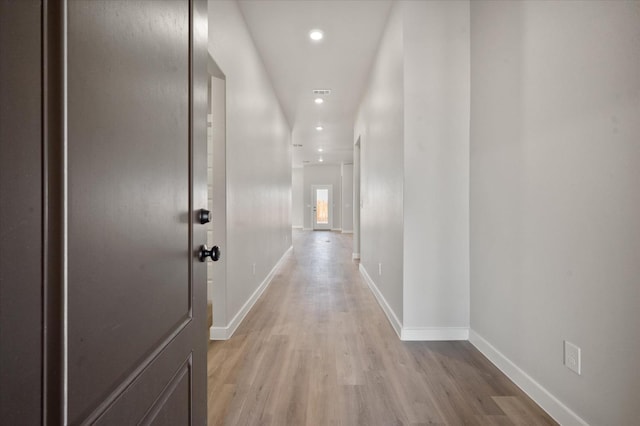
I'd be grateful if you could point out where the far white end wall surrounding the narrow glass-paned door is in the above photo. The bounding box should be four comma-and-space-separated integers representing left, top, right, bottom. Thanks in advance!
302, 165, 342, 229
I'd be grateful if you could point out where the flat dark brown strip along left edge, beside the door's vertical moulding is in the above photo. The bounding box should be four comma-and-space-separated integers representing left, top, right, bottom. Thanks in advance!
0, 0, 43, 425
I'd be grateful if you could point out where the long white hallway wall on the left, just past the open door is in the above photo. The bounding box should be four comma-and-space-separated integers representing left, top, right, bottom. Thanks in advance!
209, 1, 291, 334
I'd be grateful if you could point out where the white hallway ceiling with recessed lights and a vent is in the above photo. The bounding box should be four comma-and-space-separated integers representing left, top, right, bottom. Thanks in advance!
238, 0, 392, 167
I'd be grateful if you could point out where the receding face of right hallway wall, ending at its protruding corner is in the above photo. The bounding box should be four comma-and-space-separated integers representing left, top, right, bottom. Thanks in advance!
354, 3, 404, 326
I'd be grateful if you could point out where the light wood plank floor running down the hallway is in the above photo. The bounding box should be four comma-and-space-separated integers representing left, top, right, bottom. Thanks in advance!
208, 231, 556, 426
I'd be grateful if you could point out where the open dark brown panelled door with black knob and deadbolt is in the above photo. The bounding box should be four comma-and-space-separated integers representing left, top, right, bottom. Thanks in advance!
0, 0, 207, 425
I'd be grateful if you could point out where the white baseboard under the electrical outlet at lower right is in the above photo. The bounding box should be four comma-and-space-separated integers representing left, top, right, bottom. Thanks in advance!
469, 330, 588, 426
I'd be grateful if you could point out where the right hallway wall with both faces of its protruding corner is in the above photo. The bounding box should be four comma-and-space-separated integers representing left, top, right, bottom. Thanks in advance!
355, 1, 470, 340
